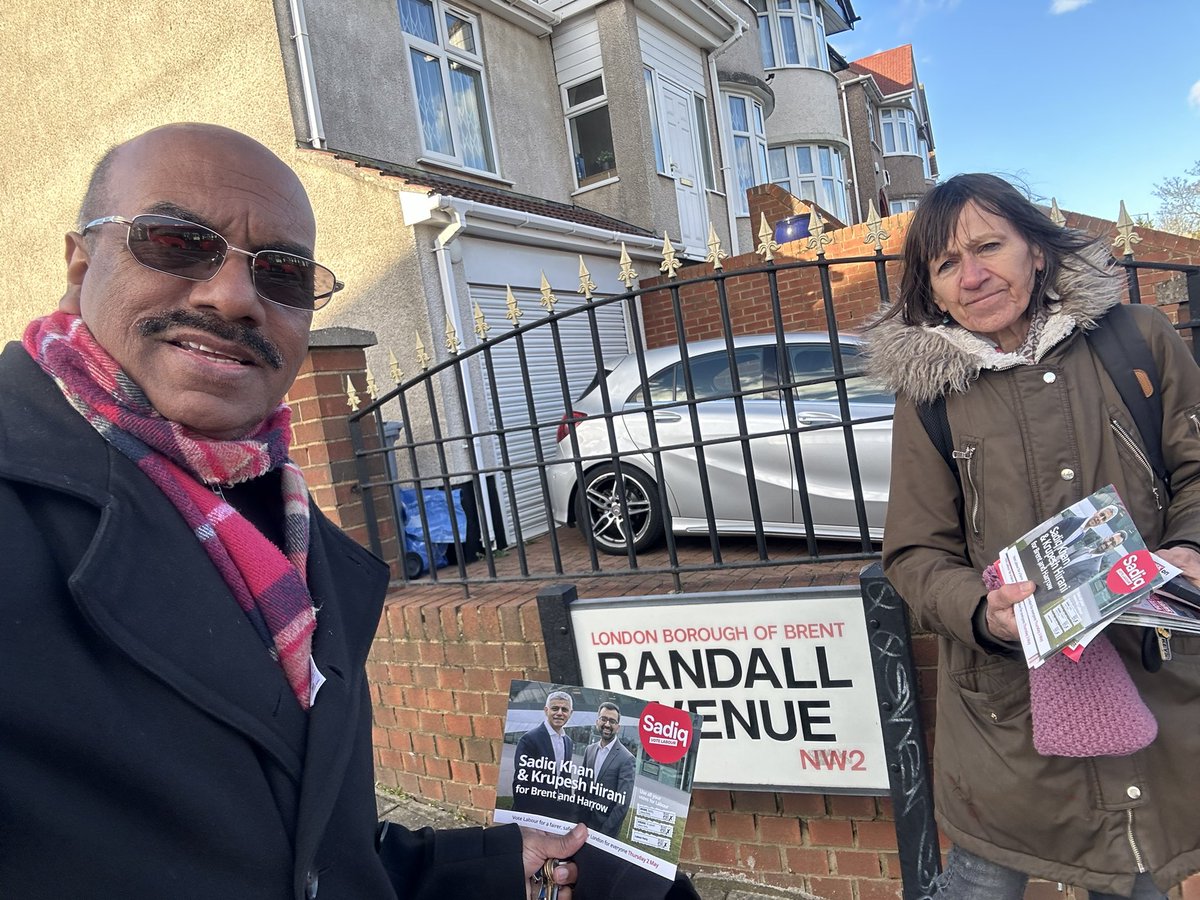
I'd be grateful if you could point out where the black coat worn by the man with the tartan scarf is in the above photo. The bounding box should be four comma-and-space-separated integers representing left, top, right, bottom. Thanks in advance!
0, 344, 524, 900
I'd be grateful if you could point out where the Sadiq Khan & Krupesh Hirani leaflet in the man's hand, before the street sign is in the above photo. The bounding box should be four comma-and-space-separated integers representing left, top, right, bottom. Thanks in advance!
494, 682, 701, 900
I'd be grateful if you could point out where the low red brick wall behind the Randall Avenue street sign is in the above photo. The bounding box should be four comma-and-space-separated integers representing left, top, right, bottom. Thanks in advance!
367, 584, 937, 900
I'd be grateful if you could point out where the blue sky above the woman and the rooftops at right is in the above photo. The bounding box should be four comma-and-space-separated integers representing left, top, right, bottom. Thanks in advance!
829, 0, 1200, 218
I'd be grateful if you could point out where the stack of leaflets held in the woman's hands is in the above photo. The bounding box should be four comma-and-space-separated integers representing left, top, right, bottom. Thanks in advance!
998, 485, 1200, 668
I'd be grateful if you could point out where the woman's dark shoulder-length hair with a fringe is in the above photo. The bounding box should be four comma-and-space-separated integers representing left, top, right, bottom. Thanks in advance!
883, 173, 1096, 325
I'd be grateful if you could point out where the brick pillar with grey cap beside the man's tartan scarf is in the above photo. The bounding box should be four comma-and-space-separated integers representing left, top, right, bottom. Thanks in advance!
287, 328, 400, 577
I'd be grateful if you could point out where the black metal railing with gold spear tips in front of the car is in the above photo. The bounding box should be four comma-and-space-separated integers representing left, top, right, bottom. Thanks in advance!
350, 210, 1200, 590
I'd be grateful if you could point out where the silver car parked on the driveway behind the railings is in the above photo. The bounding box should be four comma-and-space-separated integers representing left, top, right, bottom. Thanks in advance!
551, 334, 893, 553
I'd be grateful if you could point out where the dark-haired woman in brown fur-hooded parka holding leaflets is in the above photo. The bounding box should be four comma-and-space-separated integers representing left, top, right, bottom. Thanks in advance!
870, 174, 1200, 900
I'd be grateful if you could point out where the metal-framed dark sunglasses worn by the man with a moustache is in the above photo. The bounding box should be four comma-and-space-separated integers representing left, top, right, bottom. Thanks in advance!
83, 214, 346, 310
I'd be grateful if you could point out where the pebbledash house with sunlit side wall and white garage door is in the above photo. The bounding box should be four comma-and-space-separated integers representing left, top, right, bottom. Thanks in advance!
0, 0, 878, 547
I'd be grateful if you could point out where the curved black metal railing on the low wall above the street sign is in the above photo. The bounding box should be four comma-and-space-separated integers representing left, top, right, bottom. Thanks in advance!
350, 247, 1200, 600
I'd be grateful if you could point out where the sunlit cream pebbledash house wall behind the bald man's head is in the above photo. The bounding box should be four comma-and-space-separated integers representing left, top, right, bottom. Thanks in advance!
0, 0, 425, 343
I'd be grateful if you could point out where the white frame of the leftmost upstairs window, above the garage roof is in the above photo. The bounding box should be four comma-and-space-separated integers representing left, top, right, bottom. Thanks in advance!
397, 0, 499, 175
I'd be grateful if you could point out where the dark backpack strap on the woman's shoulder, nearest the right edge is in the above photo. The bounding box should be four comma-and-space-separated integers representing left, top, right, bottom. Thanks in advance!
1086, 304, 1171, 496
